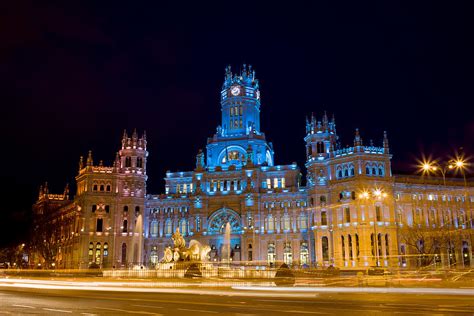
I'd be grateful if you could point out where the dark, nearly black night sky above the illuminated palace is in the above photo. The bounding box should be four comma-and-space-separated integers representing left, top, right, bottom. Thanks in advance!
0, 1, 474, 246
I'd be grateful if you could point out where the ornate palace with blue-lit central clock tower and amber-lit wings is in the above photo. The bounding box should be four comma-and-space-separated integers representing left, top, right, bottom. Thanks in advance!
34, 65, 474, 269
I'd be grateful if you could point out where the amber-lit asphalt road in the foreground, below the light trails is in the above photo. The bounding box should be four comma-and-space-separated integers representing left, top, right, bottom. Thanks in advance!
0, 289, 474, 316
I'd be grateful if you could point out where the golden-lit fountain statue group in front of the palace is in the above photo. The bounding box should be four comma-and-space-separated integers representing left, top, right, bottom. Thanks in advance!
162, 228, 211, 263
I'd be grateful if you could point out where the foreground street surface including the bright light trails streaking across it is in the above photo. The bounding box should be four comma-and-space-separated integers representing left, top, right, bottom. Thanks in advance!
0, 280, 474, 316
